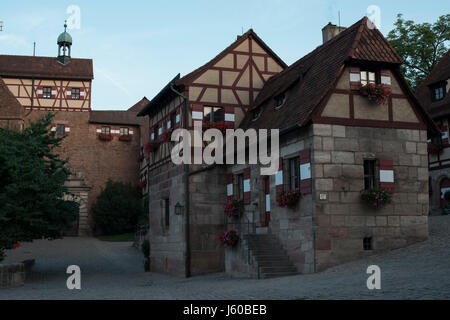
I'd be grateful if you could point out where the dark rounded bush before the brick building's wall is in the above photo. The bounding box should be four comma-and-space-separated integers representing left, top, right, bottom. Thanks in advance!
92, 179, 143, 235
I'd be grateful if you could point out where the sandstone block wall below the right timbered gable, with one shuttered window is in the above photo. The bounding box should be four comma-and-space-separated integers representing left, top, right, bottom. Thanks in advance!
313, 124, 428, 271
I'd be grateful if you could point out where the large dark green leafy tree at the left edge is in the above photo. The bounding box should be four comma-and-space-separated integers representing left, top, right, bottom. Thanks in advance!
0, 113, 79, 258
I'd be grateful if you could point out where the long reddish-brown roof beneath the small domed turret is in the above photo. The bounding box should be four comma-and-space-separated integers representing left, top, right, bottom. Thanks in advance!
0, 55, 94, 80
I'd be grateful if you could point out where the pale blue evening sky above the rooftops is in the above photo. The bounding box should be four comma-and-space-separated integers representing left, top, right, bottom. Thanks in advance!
0, 0, 450, 110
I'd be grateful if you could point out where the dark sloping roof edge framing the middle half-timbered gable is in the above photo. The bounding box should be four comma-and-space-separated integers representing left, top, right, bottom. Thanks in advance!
176, 29, 287, 85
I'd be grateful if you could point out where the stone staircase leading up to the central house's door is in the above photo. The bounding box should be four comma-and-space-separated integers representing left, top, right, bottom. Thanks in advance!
244, 233, 298, 279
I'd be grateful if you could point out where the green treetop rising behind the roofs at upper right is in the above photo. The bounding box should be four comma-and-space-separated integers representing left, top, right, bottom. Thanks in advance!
387, 14, 450, 88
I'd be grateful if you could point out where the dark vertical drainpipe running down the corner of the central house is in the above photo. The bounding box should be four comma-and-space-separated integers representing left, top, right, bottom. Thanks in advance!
170, 83, 191, 278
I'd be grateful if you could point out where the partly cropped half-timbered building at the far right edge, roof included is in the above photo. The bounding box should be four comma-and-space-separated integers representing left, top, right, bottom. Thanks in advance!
415, 51, 450, 214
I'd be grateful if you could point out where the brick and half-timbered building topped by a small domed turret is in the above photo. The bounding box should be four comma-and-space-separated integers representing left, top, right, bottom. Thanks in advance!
0, 23, 143, 235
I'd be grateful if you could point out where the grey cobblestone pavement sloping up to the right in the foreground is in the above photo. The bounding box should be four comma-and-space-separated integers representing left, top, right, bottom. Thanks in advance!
0, 216, 450, 300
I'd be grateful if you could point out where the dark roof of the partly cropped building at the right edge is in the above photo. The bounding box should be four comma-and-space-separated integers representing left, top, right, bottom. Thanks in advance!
415, 50, 450, 118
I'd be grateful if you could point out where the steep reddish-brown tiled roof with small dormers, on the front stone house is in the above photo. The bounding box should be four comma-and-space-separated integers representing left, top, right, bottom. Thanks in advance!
241, 17, 402, 129
